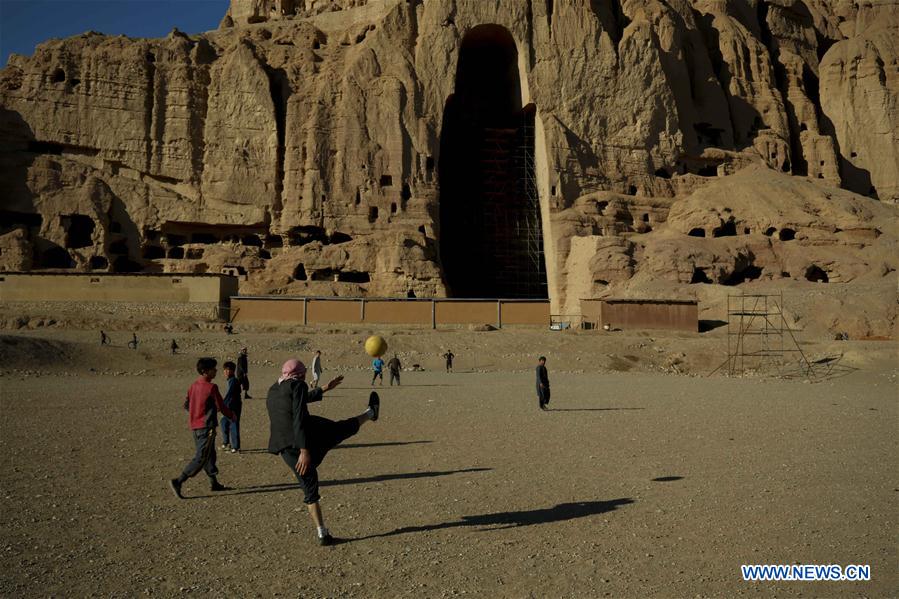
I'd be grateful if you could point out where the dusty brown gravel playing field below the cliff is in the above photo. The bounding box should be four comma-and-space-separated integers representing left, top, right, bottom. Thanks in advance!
0, 330, 899, 597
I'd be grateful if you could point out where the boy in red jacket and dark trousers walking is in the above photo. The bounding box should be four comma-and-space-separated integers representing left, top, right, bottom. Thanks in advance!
169, 358, 237, 499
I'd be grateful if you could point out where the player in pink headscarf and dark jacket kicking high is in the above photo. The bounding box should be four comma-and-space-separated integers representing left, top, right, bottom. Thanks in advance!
265, 359, 380, 545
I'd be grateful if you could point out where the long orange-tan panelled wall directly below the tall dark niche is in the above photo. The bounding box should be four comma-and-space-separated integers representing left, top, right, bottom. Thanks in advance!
231, 296, 549, 327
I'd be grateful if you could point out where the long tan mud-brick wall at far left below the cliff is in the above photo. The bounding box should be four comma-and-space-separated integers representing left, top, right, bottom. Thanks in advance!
0, 273, 237, 304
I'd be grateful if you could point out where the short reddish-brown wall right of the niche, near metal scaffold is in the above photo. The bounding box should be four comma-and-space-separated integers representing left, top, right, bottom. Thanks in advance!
581, 299, 699, 333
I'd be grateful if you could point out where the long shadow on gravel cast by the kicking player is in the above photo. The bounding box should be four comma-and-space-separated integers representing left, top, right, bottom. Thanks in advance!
356, 498, 634, 541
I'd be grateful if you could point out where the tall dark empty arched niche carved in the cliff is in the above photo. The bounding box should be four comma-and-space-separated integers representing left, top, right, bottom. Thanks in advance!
437, 25, 547, 298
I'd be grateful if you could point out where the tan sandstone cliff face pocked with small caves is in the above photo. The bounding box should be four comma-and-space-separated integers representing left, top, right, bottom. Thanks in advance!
0, 0, 899, 313
